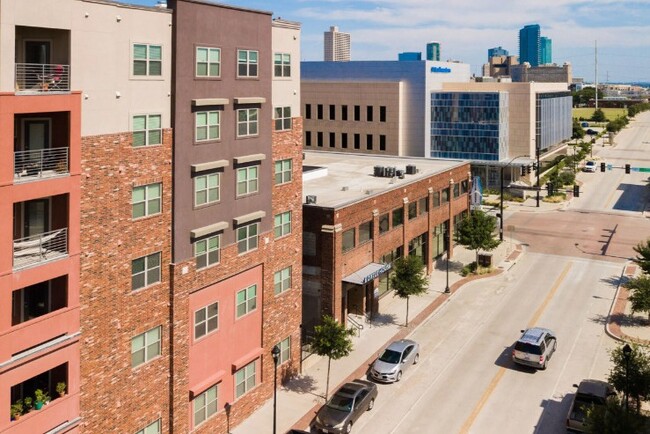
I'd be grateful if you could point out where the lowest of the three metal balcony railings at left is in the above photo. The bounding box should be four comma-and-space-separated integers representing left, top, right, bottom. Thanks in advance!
14, 228, 68, 269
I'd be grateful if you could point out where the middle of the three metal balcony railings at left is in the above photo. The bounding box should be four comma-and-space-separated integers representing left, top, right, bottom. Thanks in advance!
14, 148, 69, 182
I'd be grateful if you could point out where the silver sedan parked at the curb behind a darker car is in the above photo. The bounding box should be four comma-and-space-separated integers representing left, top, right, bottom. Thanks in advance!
370, 339, 420, 383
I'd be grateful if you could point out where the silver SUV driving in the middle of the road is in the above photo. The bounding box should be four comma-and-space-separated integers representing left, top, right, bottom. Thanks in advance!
512, 327, 557, 369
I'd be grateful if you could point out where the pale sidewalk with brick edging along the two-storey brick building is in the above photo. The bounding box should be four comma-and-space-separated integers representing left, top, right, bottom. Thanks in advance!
231, 238, 523, 434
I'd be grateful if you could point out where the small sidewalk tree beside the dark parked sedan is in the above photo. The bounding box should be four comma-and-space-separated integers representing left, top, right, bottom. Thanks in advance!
311, 315, 354, 401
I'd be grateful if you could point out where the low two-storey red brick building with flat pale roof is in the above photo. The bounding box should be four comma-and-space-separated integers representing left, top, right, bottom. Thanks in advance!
303, 151, 470, 330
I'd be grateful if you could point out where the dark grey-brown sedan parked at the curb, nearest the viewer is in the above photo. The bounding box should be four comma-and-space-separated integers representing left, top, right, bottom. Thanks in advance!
314, 380, 377, 434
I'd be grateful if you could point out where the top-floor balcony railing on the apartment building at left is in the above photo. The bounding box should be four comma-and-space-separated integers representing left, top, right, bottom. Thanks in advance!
16, 63, 70, 93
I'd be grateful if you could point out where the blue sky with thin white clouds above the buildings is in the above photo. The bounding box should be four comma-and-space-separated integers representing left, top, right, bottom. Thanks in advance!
128, 0, 650, 83
